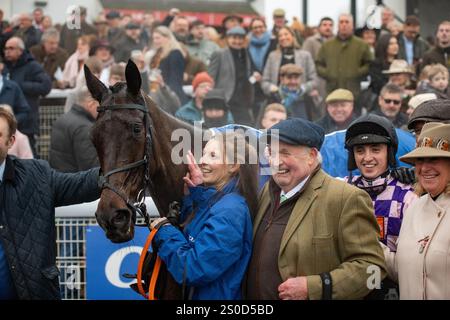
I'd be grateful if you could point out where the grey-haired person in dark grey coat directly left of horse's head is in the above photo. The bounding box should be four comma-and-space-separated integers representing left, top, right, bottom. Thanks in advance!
49, 86, 99, 172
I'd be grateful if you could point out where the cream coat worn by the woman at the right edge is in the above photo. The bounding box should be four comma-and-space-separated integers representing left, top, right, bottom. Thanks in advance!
385, 194, 450, 300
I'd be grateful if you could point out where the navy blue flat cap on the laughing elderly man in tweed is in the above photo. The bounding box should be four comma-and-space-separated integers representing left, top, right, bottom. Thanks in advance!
261, 118, 325, 150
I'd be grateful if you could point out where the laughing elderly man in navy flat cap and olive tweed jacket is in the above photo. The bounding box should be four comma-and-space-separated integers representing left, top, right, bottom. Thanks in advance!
245, 118, 386, 300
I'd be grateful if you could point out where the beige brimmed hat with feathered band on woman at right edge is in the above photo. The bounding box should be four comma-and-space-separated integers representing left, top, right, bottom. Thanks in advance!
400, 122, 450, 164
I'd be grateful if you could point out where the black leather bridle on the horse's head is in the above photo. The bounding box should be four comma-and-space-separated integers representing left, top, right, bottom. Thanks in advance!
97, 104, 153, 228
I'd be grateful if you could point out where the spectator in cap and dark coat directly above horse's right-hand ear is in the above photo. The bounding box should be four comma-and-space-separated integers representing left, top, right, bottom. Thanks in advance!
114, 22, 146, 63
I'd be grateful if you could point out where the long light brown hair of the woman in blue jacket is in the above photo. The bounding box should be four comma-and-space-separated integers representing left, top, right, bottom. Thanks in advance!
214, 132, 259, 220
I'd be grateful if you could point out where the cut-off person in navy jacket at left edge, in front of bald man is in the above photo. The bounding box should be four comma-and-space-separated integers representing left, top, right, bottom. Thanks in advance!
0, 62, 31, 130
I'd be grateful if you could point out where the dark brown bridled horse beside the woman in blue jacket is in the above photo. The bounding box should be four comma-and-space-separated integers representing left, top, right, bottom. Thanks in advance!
85, 61, 201, 299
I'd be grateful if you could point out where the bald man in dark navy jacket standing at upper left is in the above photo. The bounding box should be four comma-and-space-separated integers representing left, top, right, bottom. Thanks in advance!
3, 37, 52, 155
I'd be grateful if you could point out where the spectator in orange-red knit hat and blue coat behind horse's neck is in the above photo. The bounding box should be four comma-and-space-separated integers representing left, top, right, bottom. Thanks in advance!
175, 72, 214, 124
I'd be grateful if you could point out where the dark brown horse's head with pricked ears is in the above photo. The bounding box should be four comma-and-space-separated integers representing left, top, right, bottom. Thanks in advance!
85, 61, 152, 242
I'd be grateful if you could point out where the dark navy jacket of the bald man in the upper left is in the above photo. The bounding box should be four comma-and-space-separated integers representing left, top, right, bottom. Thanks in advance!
3, 51, 52, 134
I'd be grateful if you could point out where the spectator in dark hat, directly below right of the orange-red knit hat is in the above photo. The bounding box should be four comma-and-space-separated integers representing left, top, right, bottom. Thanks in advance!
202, 89, 234, 129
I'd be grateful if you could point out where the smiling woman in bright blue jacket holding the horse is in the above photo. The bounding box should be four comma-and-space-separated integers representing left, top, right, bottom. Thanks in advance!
152, 133, 258, 300
